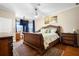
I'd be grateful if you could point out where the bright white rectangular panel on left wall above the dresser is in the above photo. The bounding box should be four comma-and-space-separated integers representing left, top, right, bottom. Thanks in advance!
0, 17, 12, 33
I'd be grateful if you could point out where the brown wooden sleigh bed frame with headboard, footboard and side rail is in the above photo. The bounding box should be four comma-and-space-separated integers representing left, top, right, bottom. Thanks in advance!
23, 25, 61, 53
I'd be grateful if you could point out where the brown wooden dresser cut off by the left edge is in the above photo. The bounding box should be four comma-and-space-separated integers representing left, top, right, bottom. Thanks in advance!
0, 33, 13, 56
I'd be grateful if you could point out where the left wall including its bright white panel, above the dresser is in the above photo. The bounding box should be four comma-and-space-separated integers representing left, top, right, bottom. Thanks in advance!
0, 9, 15, 39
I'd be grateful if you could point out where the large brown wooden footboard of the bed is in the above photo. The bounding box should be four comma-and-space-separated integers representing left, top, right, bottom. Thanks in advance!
23, 32, 44, 50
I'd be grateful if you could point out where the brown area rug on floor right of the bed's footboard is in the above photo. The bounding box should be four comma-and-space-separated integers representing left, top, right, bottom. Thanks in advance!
43, 47, 63, 56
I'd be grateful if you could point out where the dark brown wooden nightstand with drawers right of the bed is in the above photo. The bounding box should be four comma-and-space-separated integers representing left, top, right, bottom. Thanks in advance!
61, 33, 78, 47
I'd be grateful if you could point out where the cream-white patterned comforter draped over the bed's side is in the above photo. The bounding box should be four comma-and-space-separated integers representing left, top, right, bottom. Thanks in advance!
42, 32, 59, 49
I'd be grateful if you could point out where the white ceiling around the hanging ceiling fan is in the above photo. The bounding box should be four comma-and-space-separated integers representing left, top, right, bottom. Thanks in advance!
0, 3, 75, 17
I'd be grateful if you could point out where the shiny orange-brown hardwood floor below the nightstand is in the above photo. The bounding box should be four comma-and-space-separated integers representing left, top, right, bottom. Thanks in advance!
55, 44, 79, 56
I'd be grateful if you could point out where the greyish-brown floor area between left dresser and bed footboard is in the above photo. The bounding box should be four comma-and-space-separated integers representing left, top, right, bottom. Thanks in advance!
13, 40, 39, 56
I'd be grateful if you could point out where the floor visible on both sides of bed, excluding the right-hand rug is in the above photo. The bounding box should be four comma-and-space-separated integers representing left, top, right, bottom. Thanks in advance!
13, 41, 79, 56
